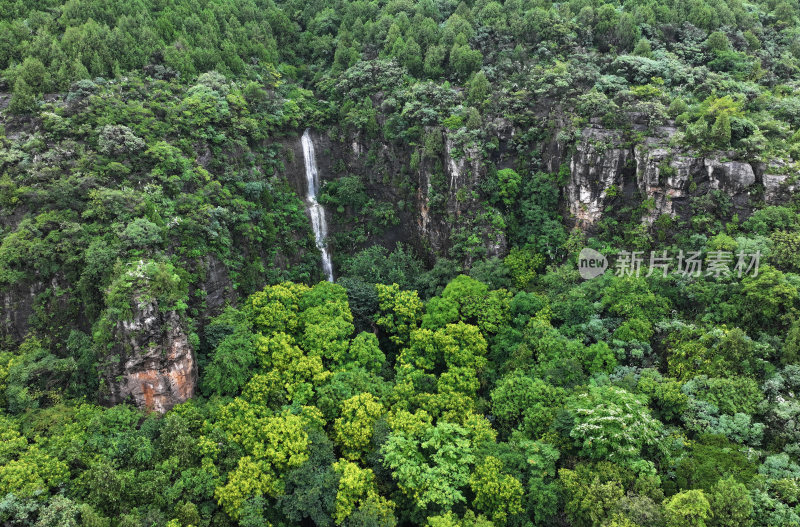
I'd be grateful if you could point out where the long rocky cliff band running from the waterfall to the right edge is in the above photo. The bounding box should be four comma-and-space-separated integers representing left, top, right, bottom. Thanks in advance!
282, 117, 796, 266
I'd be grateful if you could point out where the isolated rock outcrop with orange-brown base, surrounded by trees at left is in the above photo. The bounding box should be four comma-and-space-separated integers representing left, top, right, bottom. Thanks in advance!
104, 297, 197, 413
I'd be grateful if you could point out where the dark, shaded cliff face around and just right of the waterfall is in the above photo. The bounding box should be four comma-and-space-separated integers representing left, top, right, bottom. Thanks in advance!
280, 128, 507, 264
